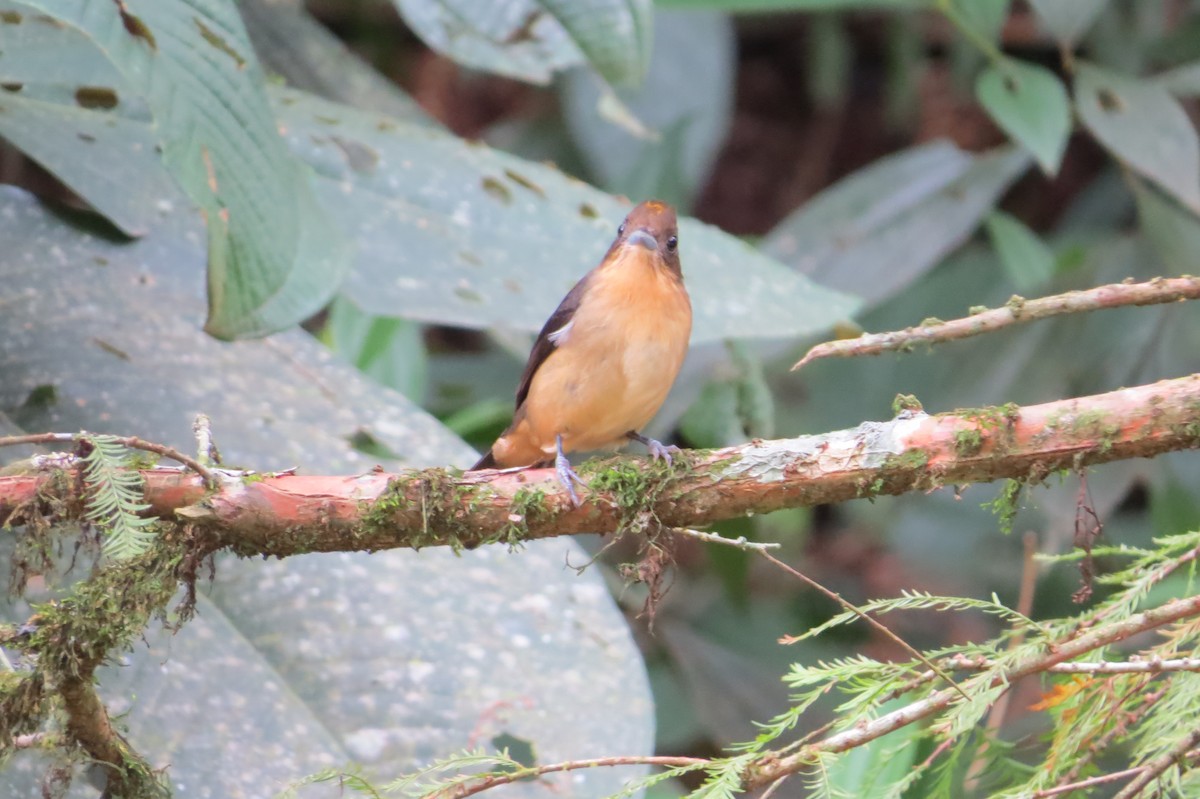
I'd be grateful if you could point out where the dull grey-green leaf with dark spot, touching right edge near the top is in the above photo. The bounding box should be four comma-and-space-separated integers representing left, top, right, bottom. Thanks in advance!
1075, 62, 1200, 212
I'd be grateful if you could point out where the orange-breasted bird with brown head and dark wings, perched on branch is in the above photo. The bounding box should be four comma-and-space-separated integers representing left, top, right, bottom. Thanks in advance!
474, 200, 691, 505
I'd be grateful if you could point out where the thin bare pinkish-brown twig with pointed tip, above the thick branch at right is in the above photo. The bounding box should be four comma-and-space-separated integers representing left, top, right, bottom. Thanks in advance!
792, 276, 1200, 372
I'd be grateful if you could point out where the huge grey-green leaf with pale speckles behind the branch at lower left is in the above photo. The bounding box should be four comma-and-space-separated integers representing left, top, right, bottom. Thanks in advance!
0, 182, 653, 797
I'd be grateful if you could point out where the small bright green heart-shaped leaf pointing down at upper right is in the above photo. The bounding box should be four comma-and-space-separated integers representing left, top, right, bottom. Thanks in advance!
976, 59, 1070, 175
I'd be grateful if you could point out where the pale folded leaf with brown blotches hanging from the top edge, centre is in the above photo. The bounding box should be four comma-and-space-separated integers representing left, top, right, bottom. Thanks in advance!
394, 0, 653, 84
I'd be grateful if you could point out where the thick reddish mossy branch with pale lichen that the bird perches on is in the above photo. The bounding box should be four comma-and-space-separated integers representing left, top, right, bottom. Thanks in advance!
0, 376, 1200, 557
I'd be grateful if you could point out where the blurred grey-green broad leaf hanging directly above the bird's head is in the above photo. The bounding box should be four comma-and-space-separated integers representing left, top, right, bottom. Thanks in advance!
559, 12, 736, 206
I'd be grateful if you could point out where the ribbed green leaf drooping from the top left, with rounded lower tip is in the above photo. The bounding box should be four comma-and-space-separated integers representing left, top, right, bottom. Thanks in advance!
18, 0, 348, 338
